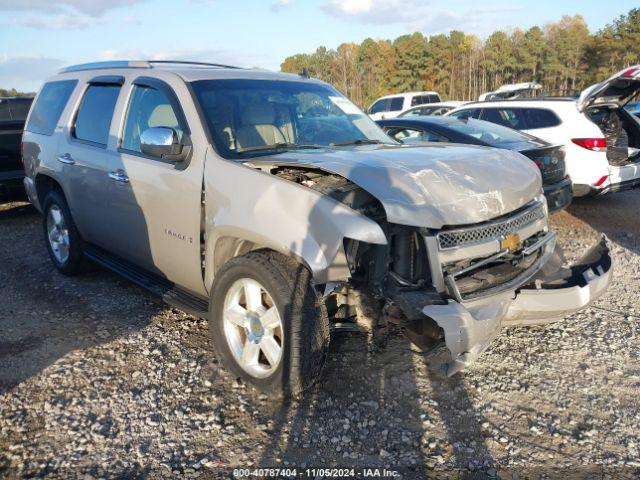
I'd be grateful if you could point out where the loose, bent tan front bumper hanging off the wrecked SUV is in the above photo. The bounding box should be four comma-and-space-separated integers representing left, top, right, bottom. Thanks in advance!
422, 236, 613, 375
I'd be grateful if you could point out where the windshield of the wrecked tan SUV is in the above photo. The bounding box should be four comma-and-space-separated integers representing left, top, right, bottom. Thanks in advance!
192, 79, 393, 158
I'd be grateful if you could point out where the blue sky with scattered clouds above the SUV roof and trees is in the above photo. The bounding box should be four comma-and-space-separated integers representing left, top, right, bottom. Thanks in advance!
0, 0, 637, 90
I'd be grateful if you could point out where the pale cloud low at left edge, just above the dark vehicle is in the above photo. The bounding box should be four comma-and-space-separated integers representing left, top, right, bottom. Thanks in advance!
0, 55, 63, 92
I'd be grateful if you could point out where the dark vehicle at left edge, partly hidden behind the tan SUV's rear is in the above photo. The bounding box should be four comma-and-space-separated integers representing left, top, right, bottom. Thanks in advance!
0, 97, 33, 196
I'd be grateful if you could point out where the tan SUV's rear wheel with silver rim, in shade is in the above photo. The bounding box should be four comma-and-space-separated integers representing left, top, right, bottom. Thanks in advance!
42, 190, 84, 276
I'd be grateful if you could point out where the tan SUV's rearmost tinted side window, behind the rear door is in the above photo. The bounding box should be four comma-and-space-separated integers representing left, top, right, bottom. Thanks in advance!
25, 80, 78, 135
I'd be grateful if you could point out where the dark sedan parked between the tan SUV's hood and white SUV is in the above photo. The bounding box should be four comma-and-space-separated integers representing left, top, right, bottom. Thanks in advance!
377, 116, 573, 212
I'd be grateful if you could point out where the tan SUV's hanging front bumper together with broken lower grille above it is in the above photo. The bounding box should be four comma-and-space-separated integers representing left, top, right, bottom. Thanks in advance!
422, 221, 613, 375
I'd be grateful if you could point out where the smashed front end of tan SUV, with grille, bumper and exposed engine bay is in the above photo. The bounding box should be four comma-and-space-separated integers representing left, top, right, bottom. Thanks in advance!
251, 158, 612, 375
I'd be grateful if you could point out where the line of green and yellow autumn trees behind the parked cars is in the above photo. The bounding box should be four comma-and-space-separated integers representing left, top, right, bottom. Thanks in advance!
281, 8, 640, 107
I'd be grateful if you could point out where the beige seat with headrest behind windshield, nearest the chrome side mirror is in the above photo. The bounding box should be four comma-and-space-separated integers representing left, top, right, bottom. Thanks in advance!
236, 103, 286, 150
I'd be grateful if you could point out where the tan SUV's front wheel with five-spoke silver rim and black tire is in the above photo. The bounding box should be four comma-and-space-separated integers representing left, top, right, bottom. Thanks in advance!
209, 250, 329, 398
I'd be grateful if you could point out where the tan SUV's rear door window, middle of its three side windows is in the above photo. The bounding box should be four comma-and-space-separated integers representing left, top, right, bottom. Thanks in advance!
73, 85, 120, 146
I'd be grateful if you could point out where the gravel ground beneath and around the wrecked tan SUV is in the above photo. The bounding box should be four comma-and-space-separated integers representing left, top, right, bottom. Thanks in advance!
0, 191, 640, 478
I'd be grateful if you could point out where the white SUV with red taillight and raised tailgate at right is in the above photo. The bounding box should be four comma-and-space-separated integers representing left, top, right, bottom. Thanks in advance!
448, 65, 640, 196
